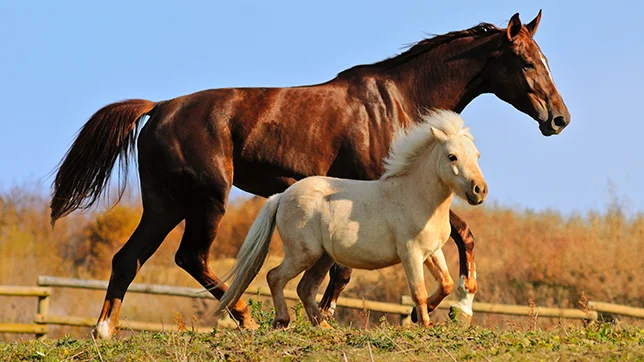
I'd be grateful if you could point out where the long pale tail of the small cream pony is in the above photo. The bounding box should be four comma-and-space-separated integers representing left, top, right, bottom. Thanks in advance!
215, 194, 281, 314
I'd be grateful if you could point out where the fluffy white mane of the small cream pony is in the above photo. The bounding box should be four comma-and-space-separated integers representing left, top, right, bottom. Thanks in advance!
380, 109, 474, 180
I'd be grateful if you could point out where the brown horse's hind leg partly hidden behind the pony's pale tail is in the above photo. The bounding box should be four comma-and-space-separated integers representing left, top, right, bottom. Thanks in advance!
175, 201, 258, 329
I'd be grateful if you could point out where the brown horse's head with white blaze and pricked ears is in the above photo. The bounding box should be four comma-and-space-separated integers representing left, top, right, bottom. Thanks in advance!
486, 11, 570, 136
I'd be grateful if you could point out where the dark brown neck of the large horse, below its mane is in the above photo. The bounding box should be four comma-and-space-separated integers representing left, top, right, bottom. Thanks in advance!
390, 35, 501, 114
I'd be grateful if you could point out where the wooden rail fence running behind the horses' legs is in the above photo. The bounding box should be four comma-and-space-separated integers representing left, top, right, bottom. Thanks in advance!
0, 276, 644, 339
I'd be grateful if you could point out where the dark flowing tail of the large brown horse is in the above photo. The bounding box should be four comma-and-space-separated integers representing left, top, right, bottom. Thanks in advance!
51, 99, 156, 225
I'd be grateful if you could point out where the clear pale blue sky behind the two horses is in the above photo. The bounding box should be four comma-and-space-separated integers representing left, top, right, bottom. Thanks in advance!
0, 0, 644, 213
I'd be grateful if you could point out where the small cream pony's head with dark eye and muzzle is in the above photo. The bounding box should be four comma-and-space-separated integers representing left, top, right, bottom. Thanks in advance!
431, 123, 487, 205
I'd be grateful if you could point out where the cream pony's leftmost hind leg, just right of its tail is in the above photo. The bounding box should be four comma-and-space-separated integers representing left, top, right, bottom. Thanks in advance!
266, 258, 313, 328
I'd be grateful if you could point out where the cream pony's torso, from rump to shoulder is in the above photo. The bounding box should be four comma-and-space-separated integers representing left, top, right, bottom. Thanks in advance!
277, 177, 399, 269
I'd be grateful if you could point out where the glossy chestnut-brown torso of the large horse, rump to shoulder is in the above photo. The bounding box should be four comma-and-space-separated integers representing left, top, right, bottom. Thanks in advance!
139, 81, 406, 202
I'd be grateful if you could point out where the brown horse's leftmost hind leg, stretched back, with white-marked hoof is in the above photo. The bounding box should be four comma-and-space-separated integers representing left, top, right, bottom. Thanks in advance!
92, 181, 183, 339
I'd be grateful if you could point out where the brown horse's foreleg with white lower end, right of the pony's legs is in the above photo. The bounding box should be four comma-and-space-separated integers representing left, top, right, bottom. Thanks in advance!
449, 210, 477, 318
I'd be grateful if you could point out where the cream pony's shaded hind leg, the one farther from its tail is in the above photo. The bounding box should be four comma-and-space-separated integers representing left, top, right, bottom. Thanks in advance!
297, 253, 333, 328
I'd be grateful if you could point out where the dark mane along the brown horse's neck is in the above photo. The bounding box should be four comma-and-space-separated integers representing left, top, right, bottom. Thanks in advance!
338, 23, 501, 76
